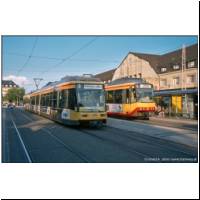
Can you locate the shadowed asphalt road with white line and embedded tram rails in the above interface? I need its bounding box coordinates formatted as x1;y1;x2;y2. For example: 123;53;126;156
2;108;197;163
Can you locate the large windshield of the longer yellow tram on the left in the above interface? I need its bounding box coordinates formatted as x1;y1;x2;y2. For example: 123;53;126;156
77;85;105;112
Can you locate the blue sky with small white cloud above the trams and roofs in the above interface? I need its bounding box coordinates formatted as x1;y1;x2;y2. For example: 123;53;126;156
2;36;198;92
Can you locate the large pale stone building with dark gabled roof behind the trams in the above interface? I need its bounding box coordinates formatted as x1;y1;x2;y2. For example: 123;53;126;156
96;44;198;118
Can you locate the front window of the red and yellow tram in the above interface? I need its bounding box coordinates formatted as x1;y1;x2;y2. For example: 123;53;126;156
136;88;153;102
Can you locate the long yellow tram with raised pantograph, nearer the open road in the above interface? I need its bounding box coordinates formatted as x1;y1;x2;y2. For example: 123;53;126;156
24;76;107;126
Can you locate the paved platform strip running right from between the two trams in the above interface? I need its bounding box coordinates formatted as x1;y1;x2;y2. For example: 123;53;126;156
107;118;198;148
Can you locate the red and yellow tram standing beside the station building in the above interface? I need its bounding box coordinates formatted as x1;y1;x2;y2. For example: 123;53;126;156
105;77;156;119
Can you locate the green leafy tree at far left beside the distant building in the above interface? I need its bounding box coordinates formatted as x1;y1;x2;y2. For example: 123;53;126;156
5;88;25;104
